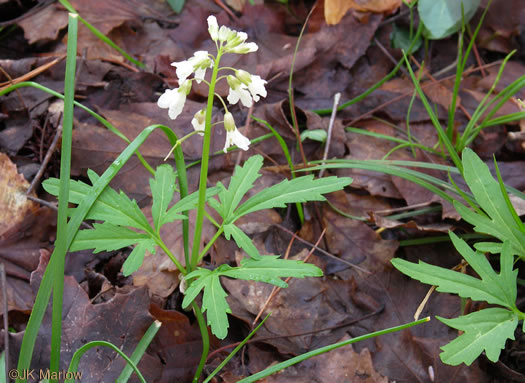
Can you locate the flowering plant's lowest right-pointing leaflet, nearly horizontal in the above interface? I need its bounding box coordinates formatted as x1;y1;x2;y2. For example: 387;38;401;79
221;255;323;287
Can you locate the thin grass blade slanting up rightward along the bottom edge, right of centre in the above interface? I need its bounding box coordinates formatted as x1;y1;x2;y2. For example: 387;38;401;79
237;317;430;383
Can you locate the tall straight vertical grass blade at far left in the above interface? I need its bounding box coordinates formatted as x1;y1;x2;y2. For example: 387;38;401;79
49;13;78;382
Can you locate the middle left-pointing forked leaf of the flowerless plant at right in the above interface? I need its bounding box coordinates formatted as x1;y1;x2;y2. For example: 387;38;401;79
392;232;518;308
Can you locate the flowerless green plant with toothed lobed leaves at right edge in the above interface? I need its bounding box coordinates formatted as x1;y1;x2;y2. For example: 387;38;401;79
392;148;525;365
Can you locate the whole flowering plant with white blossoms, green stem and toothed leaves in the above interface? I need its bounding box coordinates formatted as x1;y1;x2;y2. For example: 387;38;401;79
44;16;351;380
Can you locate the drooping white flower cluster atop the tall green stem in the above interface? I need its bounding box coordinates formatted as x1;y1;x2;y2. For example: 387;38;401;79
157;16;266;152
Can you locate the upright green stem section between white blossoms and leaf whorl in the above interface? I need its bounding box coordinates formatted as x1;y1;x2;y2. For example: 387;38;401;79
188;48;222;272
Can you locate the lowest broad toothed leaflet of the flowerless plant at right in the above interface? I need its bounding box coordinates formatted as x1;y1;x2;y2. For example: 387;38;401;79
437;308;518;366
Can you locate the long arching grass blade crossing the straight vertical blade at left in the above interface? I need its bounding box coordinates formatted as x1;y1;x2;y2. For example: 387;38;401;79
17;125;177;382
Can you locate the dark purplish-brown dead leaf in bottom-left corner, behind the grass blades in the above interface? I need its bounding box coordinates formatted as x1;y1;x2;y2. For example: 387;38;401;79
10;257;162;382
